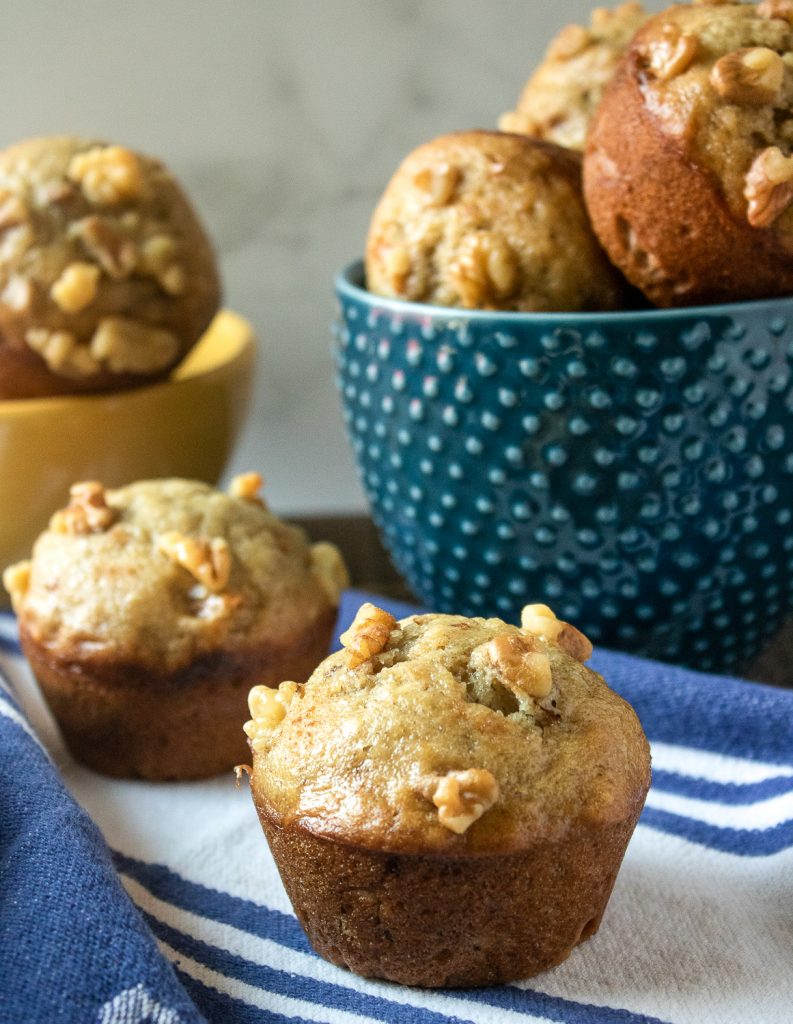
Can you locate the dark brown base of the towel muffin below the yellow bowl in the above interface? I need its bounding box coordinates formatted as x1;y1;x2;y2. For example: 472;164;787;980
19;609;336;781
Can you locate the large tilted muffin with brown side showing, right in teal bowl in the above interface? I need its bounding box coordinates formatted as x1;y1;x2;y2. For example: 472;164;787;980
584;0;793;306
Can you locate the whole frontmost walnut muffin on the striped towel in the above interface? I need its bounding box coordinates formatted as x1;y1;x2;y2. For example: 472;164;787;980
246;604;650;987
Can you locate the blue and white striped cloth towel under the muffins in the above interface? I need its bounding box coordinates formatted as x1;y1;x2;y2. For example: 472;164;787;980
0;594;793;1024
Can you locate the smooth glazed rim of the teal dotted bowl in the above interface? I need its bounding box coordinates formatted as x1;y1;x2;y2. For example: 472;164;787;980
334;259;793;326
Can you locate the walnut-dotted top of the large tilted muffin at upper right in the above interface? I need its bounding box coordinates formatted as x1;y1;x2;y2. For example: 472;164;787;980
627;0;793;232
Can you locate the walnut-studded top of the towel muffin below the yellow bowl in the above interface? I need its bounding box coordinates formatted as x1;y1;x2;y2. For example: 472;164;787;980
3;473;346;672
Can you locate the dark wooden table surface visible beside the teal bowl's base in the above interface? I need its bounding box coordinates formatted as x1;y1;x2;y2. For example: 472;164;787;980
296;515;793;687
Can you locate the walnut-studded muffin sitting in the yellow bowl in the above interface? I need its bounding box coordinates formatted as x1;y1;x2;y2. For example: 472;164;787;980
0;136;220;398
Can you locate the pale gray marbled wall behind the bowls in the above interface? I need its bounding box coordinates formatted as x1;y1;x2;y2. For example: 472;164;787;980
0;0;663;513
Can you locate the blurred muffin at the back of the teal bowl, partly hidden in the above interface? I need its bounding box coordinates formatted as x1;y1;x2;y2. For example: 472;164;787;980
499;0;650;150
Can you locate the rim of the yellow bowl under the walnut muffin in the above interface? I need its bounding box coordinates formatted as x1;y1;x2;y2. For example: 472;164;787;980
0;307;254;421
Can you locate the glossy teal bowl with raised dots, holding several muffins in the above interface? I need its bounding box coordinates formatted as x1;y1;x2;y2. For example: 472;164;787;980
335;262;793;671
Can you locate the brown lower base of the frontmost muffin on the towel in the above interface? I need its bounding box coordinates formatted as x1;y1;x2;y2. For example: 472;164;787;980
254;791;640;988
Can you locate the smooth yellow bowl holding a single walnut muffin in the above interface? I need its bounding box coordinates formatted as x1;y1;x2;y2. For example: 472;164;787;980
0;310;255;585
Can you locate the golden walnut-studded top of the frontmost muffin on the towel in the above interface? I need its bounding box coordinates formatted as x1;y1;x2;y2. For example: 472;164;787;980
246;604;650;853
